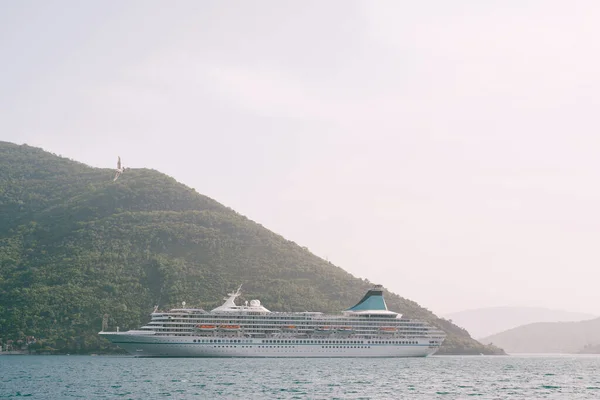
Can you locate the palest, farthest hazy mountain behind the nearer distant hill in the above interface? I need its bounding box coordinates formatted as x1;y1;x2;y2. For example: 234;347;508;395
444;307;597;343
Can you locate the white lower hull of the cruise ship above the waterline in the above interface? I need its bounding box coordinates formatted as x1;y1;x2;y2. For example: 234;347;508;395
100;332;438;358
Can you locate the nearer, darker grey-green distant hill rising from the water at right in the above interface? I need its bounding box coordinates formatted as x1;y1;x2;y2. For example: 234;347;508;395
480;318;600;353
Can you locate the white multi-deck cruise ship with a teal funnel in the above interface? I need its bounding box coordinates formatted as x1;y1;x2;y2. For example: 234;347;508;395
99;285;446;357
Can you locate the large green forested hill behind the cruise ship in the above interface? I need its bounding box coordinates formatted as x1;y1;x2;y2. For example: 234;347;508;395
0;142;502;354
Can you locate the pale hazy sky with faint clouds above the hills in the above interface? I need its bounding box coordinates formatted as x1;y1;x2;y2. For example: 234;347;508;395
0;0;600;314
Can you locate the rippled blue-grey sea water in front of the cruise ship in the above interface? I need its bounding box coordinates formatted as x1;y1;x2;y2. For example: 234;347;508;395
0;356;600;399
